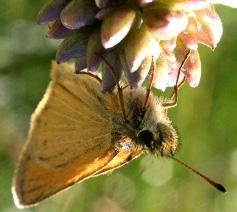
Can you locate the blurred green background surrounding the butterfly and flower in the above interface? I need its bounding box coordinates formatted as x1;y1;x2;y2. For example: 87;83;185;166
0;0;237;212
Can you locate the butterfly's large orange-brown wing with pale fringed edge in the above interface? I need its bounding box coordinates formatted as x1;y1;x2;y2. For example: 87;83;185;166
13;62;128;207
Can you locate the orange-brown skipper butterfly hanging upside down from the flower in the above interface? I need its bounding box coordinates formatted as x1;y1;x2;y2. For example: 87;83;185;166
12;51;226;208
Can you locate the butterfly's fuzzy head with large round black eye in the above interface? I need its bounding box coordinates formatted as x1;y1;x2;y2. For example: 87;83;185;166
137;123;178;156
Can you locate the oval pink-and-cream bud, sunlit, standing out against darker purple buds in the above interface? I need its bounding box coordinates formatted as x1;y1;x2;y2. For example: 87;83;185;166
101;7;136;49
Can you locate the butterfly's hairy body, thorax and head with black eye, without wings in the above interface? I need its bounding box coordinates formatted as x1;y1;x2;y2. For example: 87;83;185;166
112;90;178;156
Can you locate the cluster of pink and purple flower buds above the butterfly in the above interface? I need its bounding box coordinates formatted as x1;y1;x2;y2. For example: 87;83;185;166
38;0;234;92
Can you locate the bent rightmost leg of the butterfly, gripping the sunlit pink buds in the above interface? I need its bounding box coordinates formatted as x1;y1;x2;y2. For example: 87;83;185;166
162;50;191;109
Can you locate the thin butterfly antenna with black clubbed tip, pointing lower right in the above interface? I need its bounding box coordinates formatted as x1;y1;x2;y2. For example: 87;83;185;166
170;156;226;192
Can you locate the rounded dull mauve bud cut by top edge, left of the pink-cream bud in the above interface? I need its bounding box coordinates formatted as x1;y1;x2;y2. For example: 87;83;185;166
60;0;97;29
